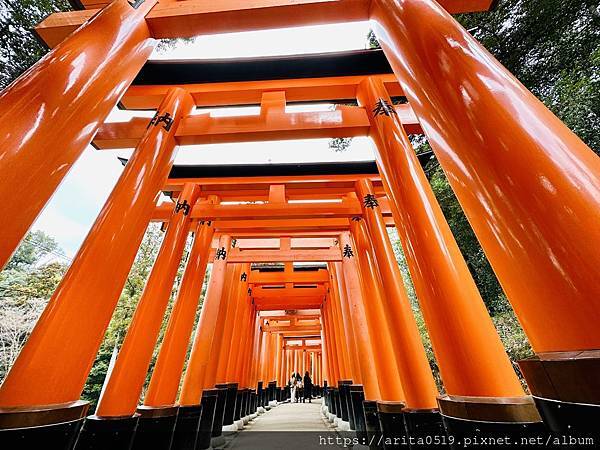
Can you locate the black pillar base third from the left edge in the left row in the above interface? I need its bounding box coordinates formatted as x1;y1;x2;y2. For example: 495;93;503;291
131;406;178;450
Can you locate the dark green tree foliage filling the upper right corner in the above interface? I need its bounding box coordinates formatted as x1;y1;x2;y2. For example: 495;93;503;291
458;0;600;153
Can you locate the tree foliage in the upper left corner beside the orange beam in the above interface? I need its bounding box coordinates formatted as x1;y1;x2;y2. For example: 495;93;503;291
0;0;70;89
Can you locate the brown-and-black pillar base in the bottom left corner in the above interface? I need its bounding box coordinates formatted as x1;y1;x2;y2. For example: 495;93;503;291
0;400;89;450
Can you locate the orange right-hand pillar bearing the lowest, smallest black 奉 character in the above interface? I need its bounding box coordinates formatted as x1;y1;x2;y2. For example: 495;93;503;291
338;232;381;400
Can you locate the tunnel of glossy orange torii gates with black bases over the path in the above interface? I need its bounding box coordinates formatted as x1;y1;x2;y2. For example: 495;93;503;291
0;0;600;449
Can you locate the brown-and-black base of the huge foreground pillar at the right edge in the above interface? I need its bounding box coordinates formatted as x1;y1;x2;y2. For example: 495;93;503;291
519;350;600;435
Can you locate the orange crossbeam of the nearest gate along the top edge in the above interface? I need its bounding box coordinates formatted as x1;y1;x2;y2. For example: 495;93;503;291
35;0;493;47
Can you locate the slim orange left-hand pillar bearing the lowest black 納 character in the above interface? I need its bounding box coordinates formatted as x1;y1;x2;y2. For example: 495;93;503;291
179;235;231;405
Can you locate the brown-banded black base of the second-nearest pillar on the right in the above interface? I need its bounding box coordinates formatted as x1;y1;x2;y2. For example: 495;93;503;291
438;396;547;448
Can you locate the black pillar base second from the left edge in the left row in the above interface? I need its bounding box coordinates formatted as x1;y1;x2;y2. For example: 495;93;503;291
73;414;139;450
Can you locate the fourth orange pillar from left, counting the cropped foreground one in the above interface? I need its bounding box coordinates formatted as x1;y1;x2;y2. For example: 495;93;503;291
144;218;214;406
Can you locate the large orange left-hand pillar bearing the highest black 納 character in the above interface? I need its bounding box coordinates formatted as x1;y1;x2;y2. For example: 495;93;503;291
0;89;193;407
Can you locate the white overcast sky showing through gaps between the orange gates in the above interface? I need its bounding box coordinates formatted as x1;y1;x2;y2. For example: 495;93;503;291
32;22;373;258
